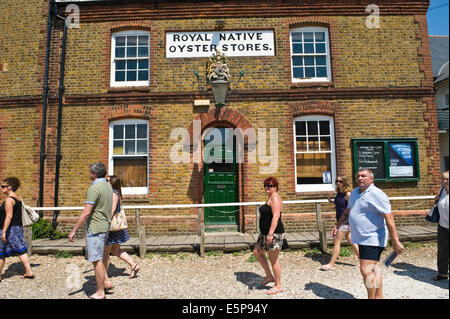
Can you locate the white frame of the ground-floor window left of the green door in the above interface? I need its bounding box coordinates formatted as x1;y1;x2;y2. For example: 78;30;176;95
108;119;150;195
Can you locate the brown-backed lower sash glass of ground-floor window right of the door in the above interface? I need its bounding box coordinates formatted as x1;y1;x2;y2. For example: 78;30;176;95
296;153;331;184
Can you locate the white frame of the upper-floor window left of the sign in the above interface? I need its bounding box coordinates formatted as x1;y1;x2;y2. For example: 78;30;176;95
110;31;151;87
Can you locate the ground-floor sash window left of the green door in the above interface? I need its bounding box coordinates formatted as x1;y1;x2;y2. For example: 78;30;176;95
109;119;148;194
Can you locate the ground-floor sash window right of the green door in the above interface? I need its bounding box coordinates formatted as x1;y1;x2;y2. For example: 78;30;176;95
294;116;337;192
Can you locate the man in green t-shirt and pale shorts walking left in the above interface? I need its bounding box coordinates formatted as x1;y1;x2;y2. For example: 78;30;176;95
69;162;113;299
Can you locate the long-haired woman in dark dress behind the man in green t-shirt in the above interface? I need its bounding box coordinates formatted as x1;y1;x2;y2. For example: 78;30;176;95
103;175;140;287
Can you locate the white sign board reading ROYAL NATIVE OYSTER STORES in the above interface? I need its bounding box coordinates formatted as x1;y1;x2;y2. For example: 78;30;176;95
166;30;275;58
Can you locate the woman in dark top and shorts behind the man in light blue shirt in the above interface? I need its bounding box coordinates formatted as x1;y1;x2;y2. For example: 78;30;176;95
320;176;359;271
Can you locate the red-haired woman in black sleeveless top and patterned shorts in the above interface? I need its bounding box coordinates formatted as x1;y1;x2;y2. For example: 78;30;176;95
253;177;285;295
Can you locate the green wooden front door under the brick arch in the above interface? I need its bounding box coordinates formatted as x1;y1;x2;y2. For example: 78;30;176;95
203;128;239;225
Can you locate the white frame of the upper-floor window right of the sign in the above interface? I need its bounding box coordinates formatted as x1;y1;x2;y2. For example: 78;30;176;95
289;27;332;83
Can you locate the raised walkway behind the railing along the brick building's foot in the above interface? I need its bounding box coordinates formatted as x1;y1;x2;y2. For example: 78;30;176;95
33;225;437;255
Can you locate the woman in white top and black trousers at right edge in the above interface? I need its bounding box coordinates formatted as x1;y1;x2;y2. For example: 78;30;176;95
433;171;449;280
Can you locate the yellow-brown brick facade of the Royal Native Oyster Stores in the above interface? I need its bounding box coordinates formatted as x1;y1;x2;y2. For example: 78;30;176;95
0;0;439;238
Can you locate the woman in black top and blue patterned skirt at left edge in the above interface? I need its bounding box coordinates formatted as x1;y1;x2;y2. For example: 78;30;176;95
0;177;34;281
